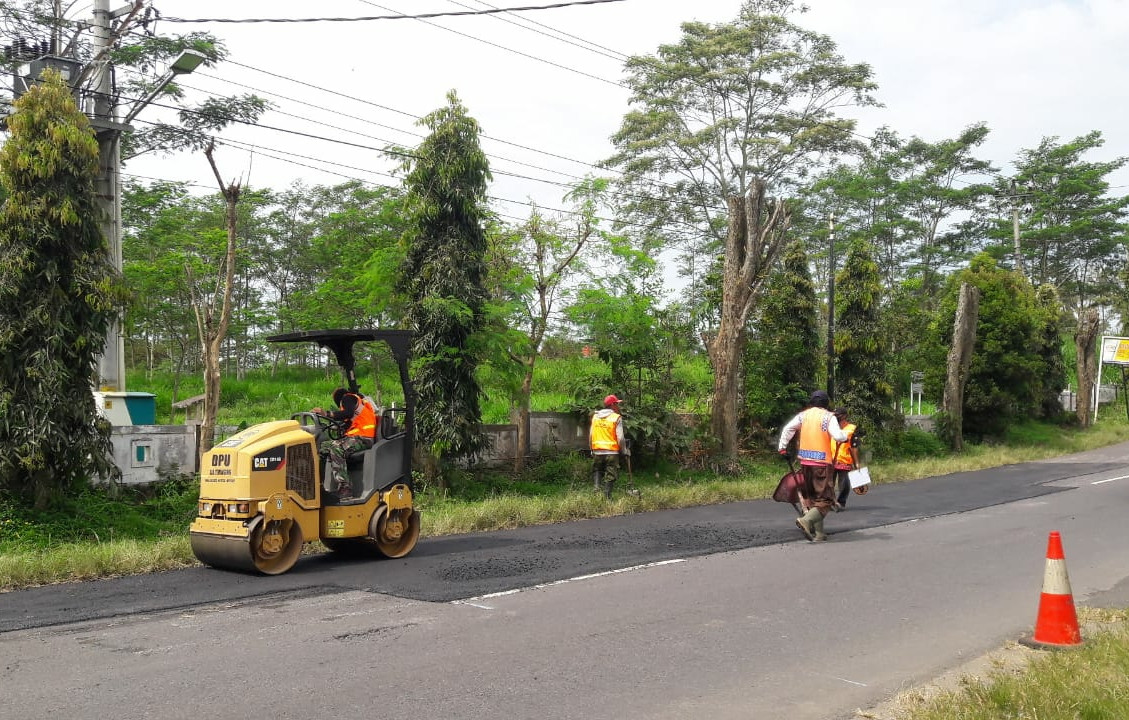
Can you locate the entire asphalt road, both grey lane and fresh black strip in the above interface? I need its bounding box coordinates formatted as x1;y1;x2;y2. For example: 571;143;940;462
0;444;1129;720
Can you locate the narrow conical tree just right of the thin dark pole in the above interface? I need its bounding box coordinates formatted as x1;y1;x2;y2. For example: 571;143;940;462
834;239;894;430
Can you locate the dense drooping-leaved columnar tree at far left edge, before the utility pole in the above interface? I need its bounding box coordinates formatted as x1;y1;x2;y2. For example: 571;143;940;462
0;72;124;508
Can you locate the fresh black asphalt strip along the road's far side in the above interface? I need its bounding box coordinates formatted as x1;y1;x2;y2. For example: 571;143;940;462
0;462;1124;632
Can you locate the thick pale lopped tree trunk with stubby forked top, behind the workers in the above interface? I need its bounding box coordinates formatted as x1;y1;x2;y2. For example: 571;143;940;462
707;178;791;459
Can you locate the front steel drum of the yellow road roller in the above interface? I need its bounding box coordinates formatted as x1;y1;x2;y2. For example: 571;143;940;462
189;516;304;576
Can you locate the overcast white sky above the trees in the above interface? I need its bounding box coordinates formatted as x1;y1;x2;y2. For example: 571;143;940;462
124;0;1129;225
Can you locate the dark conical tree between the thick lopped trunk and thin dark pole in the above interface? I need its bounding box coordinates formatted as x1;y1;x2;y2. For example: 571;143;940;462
744;240;823;428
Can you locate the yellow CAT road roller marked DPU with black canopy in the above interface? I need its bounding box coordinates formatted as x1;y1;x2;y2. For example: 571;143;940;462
189;330;420;574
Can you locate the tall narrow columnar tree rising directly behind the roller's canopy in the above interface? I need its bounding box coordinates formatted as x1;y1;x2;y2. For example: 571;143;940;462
399;90;490;482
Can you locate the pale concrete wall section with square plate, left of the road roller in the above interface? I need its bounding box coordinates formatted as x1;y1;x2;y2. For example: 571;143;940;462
110;425;198;485
